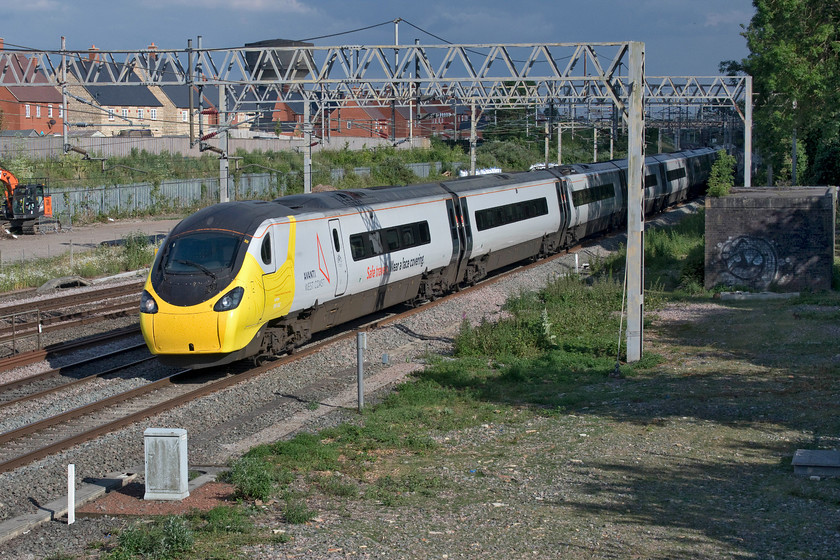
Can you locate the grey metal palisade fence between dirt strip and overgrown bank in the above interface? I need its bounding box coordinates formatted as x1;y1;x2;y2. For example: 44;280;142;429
51;161;463;227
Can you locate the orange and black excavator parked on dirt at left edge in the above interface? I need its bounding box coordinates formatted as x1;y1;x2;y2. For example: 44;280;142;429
0;168;60;233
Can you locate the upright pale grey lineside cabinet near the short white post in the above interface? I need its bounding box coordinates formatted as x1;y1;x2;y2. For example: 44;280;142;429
143;428;190;500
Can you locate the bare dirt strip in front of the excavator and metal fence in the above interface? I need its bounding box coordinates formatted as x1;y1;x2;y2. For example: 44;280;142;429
0;218;180;264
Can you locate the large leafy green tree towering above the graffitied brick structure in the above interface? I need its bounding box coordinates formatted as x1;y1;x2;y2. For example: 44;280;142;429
736;0;840;184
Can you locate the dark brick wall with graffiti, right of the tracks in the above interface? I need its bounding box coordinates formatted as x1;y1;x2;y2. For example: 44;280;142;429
705;187;837;292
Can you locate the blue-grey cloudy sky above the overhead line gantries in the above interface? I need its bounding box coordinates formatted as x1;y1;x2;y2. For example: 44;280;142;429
0;0;755;76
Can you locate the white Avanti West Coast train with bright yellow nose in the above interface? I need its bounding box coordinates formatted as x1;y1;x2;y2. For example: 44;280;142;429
140;148;716;369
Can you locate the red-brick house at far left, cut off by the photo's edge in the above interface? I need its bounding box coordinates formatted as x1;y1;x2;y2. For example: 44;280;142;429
0;39;64;135
